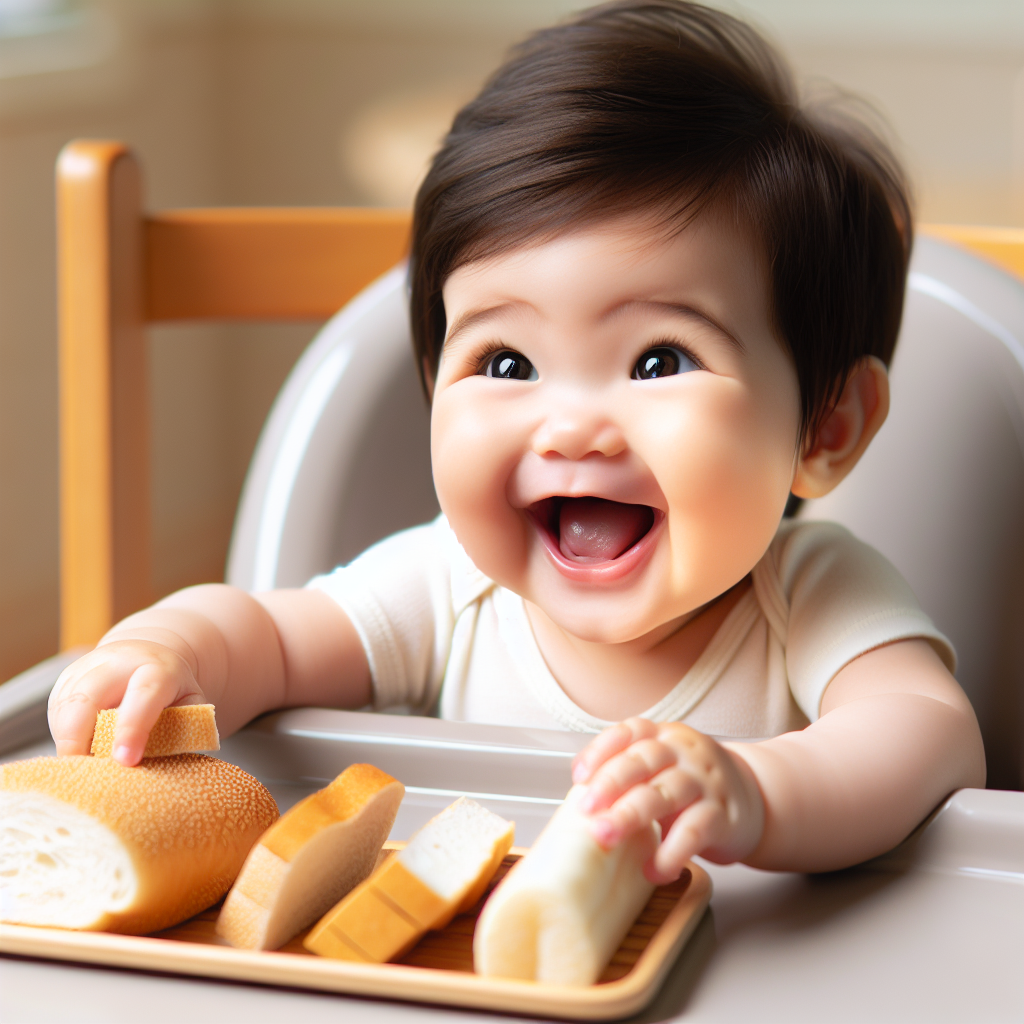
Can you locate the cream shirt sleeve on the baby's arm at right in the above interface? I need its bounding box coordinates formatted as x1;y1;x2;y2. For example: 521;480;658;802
772;522;956;722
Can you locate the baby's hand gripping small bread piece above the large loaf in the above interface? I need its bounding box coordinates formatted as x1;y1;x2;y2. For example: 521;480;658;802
48;631;207;766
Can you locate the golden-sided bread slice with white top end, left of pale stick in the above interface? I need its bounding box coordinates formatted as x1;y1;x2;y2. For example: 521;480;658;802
303;797;515;964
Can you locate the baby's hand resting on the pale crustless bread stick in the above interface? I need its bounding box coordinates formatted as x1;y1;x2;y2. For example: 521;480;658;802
572;718;765;885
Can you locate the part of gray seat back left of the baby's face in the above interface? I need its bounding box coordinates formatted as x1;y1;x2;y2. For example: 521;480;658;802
226;266;438;591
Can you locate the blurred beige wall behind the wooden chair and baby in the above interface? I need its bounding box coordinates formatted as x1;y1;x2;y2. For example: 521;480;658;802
0;0;1024;679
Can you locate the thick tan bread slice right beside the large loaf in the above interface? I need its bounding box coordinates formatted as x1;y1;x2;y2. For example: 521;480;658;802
217;765;406;949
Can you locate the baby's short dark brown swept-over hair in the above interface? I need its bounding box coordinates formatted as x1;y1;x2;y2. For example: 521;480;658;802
410;0;911;438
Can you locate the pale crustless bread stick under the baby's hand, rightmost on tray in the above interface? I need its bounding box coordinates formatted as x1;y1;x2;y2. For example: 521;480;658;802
473;786;660;985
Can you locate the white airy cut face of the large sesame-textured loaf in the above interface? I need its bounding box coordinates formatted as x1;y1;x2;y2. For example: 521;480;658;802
0;792;138;928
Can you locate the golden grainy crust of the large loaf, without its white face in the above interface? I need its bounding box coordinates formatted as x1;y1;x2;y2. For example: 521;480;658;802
0;754;278;935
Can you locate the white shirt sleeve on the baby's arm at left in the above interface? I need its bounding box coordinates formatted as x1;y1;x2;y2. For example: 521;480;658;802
306;519;454;713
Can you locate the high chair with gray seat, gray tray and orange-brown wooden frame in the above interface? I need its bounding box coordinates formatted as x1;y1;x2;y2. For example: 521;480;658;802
0;142;1024;1022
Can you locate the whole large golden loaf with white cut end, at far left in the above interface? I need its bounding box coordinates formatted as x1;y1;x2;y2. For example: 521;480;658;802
0;754;278;935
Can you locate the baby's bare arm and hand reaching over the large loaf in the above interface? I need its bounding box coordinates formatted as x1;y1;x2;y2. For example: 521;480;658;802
49;584;370;765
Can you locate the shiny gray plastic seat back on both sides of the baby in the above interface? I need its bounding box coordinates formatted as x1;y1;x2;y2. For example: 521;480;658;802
227;238;1024;788
